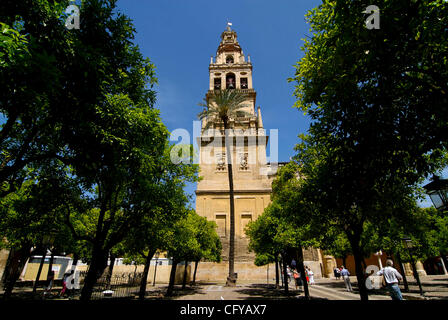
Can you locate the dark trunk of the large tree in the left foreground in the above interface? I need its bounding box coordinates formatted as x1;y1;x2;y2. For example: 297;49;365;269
80;244;109;301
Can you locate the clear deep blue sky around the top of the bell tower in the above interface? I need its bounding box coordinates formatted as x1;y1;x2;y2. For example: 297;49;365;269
114;0;440;206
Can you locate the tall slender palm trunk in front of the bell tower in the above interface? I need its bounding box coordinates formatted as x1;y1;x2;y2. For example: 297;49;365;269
224;119;236;287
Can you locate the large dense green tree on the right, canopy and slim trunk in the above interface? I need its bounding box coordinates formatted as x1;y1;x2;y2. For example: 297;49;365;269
291;0;448;299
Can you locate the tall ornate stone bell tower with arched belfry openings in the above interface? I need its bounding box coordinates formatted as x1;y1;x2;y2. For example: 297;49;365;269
196;26;274;280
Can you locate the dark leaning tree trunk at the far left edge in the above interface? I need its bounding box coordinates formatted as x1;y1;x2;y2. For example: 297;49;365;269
3;246;31;300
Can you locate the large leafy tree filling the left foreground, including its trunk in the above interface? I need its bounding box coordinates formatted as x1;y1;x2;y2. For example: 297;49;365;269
0;0;196;300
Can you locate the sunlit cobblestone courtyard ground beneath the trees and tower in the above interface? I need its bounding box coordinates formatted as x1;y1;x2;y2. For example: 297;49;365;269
0;276;448;300
